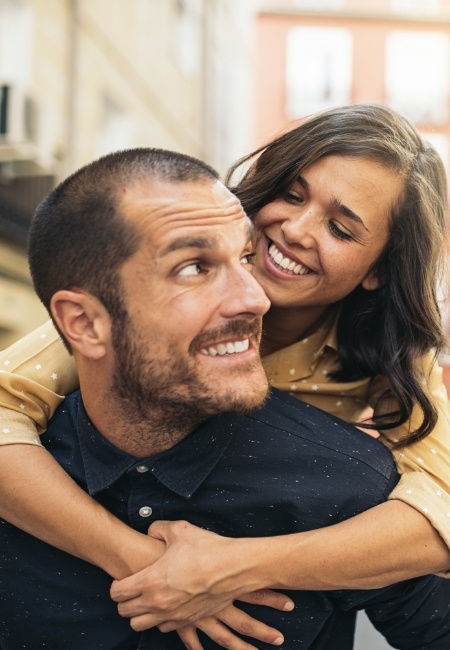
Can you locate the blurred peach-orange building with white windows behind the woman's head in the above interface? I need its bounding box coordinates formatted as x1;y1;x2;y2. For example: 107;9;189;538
253;0;450;167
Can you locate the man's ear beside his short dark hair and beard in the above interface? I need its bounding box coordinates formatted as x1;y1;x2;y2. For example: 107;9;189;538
50;289;111;360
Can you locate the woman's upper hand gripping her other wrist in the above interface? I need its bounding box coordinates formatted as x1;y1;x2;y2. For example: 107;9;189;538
111;521;293;632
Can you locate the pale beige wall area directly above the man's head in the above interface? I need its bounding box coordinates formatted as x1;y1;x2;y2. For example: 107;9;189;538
22;0;255;175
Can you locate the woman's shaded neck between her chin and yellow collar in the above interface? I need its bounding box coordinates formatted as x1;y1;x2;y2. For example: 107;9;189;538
261;306;330;357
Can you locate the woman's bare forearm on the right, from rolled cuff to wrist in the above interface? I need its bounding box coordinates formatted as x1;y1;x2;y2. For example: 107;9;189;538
258;500;450;590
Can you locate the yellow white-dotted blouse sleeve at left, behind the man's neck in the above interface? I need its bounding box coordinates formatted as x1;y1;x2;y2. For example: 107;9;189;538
0;321;78;445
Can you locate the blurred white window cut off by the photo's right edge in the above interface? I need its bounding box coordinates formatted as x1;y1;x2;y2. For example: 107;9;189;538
386;31;450;124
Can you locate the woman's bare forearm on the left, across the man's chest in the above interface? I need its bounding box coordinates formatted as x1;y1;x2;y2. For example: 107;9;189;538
0;445;163;579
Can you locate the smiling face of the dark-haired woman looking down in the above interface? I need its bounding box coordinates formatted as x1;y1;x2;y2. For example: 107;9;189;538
254;155;404;308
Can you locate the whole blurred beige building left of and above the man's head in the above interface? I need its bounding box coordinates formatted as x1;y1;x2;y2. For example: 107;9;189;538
0;0;254;348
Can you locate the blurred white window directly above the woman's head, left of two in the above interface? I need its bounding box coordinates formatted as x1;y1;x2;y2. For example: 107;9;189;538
286;27;352;119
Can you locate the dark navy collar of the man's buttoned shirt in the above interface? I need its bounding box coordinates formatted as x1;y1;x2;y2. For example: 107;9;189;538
77;397;233;498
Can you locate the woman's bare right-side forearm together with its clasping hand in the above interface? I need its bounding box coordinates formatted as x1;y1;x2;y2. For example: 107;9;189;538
111;500;450;631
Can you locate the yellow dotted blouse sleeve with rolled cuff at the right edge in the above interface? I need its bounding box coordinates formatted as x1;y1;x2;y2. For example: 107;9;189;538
372;354;450;556
